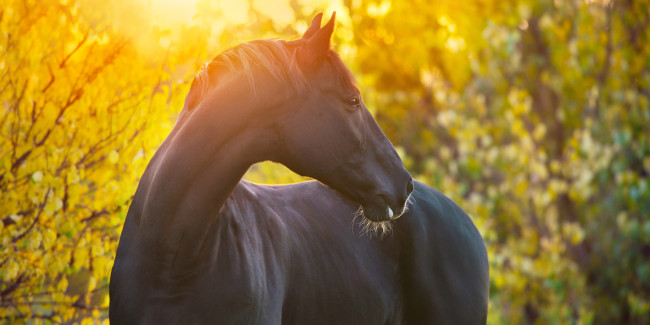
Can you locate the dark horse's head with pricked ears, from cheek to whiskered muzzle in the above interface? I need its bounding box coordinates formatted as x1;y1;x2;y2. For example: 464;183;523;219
273;14;413;221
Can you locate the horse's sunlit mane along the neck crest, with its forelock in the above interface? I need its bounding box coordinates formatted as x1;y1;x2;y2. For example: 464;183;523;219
185;39;355;110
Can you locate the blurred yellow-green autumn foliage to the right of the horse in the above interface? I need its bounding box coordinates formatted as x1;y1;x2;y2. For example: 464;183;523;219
348;1;650;323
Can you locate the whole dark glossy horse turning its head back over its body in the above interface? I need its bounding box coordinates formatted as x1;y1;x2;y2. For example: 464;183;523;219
110;14;488;324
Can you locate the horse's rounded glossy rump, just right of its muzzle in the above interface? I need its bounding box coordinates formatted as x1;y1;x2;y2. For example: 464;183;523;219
398;183;489;324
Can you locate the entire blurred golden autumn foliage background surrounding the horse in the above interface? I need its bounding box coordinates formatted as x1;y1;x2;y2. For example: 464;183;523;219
0;0;650;324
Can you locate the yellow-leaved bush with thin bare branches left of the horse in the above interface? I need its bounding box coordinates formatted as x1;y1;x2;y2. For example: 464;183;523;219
0;1;196;322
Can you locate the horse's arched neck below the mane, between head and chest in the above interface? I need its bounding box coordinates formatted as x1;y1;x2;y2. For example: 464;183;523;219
132;73;280;258
